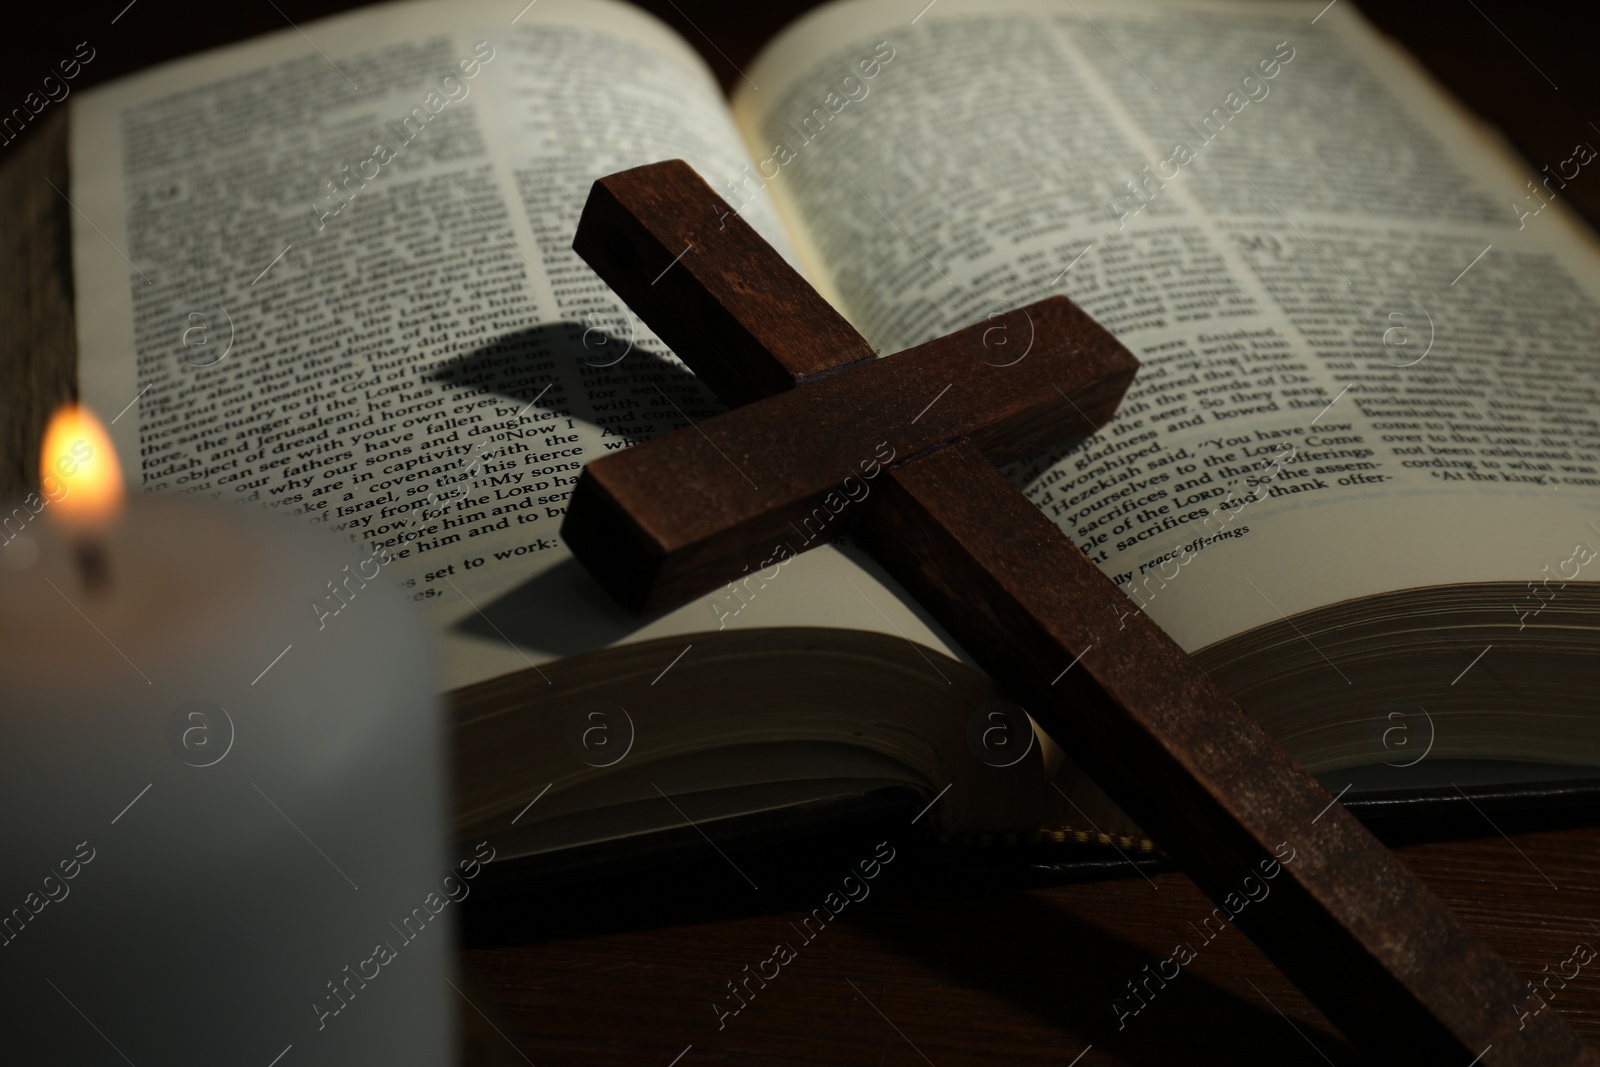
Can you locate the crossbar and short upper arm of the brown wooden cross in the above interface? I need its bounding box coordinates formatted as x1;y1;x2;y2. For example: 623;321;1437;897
562;160;1138;611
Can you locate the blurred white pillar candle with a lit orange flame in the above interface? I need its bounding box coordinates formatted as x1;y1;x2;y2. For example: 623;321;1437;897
0;408;451;1067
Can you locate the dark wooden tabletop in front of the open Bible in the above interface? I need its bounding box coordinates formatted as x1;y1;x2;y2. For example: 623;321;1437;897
462;825;1600;1067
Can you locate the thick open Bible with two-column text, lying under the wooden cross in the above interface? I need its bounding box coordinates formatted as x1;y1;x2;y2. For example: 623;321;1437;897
70;0;1600;857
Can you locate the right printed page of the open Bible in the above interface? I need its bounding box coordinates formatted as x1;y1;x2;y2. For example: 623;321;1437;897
734;0;1600;652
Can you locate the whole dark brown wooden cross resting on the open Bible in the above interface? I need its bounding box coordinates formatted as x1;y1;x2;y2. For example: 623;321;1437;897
562;160;1600;1067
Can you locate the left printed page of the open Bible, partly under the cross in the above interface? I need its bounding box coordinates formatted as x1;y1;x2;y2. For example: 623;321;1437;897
70;0;966;686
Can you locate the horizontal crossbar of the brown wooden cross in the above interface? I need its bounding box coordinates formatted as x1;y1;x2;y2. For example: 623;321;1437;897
562;298;1138;611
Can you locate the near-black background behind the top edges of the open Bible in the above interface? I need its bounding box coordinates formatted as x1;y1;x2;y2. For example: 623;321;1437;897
9;0;1600;224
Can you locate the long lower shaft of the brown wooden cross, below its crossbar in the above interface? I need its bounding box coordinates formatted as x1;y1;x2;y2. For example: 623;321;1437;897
858;442;1600;1064
